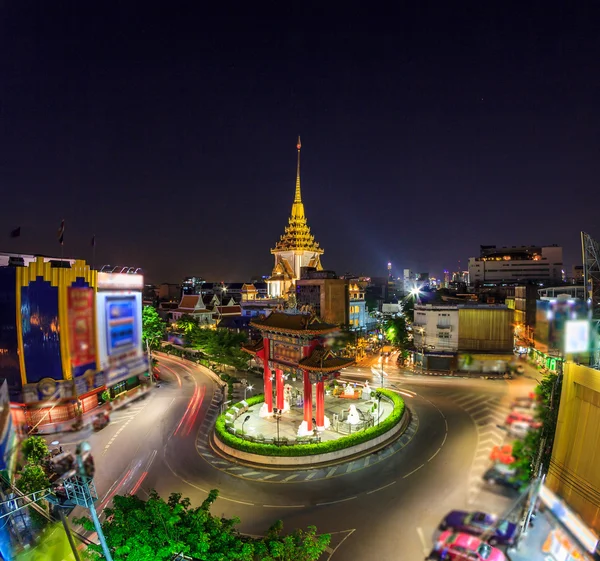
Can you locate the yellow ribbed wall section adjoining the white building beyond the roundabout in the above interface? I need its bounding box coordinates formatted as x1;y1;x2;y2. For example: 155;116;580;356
458;308;514;352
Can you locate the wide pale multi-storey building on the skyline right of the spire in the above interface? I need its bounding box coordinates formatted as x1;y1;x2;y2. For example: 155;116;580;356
469;245;563;285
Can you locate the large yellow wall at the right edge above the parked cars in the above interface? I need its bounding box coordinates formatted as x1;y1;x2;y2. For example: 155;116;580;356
547;362;600;533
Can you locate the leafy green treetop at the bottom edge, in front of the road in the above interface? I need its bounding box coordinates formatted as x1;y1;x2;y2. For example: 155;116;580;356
75;490;330;561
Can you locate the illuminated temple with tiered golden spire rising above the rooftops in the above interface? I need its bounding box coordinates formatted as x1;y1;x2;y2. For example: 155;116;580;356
267;137;323;298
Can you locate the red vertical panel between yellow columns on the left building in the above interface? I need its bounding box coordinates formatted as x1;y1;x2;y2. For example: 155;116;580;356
67;287;96;377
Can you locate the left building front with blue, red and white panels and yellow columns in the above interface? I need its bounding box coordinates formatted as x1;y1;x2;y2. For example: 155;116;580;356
0;257;148;432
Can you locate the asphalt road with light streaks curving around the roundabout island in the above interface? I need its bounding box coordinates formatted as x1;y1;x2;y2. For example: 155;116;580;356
71;358;534;561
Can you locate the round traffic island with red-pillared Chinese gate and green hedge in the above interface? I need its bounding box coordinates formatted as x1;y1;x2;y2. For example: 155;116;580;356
214;310;410;469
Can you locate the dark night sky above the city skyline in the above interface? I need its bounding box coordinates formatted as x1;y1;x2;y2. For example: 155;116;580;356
0;4;600;282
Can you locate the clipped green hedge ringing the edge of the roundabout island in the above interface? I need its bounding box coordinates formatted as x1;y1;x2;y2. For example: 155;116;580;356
215;389;404;456
